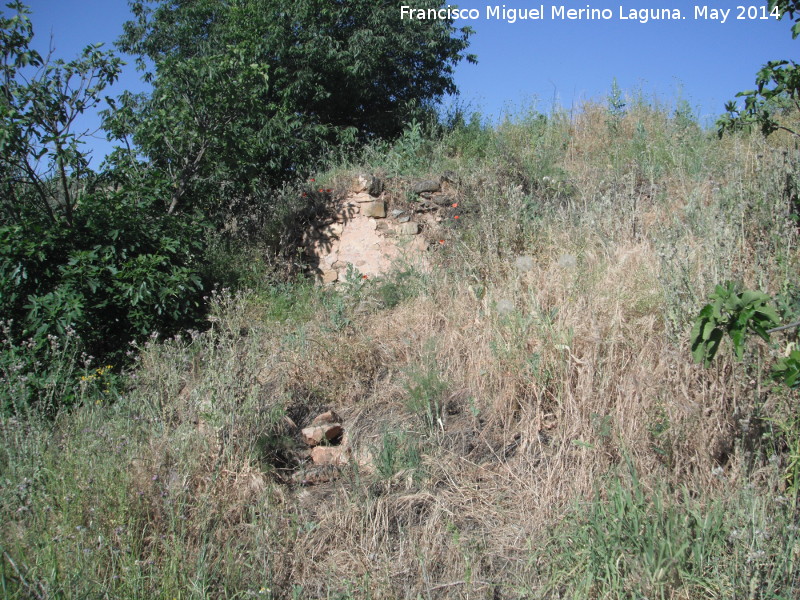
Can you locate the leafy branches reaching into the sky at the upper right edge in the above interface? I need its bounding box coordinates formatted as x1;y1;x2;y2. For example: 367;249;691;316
717;0;800;137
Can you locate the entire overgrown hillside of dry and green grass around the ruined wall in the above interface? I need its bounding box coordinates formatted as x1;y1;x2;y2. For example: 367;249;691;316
0;98;800;600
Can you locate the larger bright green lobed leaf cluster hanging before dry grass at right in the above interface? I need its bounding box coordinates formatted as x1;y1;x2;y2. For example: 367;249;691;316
690;282;779;367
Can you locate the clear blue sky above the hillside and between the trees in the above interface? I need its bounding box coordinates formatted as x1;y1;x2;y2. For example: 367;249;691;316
17;0;800;166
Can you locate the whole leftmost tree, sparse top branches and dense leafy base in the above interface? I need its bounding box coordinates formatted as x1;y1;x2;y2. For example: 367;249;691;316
0;2;206;411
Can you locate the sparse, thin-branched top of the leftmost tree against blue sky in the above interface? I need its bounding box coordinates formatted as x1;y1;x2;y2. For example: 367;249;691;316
0;0;122;227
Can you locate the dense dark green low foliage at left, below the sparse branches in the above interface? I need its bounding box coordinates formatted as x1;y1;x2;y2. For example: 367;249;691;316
0;192;205;410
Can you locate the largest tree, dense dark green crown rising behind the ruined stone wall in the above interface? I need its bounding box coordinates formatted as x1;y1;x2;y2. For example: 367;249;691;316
109;0;475;216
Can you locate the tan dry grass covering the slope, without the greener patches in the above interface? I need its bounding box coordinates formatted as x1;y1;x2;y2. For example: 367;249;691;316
3;101;800;599
